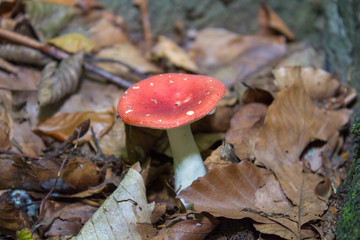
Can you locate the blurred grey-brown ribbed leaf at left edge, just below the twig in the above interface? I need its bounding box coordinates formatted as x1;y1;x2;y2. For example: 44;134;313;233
0;44;51;66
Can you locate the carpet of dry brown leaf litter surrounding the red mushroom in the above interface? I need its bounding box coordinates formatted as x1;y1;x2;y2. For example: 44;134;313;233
0;0;357;239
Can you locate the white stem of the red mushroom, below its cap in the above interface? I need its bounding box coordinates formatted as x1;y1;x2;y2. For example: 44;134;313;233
167;124;206;197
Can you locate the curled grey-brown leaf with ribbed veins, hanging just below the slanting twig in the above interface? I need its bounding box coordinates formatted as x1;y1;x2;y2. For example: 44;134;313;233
38;52;84;106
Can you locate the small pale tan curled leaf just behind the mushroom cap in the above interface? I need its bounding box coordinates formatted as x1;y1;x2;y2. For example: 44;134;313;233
152;36;198;73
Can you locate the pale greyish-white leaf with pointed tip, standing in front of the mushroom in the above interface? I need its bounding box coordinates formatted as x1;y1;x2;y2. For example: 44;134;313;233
72;168;155;240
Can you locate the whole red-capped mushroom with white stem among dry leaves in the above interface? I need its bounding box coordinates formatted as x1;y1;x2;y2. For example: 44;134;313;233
118;73;226;206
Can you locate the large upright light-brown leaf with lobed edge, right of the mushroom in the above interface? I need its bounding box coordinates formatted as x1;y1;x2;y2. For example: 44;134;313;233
255;81;342;204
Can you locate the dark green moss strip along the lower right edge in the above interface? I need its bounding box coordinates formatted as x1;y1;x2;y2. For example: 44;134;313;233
337;113;360;240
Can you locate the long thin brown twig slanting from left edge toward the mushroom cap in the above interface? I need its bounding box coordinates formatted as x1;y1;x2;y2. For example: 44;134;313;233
0;28;133;88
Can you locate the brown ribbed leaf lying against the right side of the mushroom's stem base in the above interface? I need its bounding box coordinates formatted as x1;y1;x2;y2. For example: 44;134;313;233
177;161;269;220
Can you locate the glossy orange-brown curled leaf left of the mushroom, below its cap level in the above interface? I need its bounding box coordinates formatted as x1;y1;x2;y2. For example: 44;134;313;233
34;106;115;141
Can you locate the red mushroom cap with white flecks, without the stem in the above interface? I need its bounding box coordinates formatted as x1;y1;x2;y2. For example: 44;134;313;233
118;73;226;129
